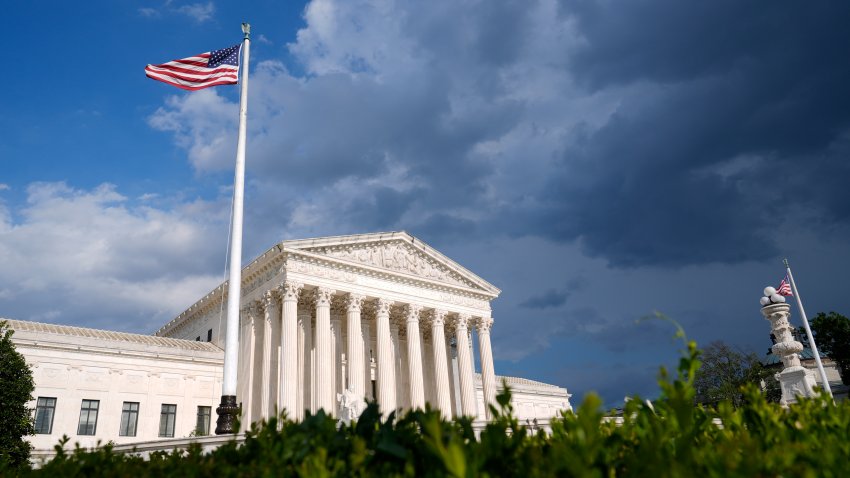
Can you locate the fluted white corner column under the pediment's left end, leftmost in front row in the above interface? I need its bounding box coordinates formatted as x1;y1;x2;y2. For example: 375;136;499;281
280;281;304;419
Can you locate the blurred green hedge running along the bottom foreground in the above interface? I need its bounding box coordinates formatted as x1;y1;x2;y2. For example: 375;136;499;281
6;336;850;478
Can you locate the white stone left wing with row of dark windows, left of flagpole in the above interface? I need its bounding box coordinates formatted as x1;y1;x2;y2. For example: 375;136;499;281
8;320;224;457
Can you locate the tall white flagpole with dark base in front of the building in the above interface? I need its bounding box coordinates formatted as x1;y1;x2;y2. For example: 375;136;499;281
215;23;251;435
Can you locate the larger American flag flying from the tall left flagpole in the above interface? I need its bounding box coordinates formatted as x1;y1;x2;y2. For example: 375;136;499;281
145;44;242;91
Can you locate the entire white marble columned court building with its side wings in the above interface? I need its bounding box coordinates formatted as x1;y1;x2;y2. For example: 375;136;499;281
9;232;570;449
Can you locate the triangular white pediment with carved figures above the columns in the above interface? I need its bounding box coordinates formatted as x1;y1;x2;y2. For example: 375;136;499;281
281;232;500;296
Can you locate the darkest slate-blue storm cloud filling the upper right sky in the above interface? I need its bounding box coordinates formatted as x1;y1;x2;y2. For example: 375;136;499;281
523;1;850;266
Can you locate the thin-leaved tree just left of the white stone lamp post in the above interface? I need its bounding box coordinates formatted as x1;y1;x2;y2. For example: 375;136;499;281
694;341;779;408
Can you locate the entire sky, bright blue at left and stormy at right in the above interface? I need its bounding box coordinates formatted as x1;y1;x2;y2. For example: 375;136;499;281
0;0;850;404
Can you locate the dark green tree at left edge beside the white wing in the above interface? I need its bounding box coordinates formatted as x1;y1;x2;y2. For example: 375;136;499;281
0;321;35;469
